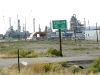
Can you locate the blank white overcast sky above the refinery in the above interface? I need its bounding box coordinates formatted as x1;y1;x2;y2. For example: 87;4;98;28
0;0;100;34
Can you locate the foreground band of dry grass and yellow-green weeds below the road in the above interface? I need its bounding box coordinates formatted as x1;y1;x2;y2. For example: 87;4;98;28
0;59;100;75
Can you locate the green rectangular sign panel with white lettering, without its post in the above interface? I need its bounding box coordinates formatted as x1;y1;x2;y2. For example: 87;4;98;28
52;20;67;29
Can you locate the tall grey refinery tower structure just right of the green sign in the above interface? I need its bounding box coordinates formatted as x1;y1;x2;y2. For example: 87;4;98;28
70;14;85;40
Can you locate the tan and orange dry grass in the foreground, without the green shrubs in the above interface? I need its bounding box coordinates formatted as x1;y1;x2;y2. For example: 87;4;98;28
1;63;100;75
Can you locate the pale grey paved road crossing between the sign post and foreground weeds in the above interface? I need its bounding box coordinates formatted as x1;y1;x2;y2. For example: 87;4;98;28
0;56;96;69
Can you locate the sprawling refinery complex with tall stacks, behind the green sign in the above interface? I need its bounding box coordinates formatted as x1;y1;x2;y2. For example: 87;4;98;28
0;14;95;40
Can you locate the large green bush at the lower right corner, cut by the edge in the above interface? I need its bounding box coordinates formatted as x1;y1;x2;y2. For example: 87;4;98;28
88;57;100;72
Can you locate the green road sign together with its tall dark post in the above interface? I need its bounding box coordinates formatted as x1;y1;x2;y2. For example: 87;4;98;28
52;20;67;57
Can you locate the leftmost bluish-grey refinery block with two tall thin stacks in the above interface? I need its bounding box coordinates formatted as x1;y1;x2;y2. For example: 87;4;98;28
4;18;30;40
